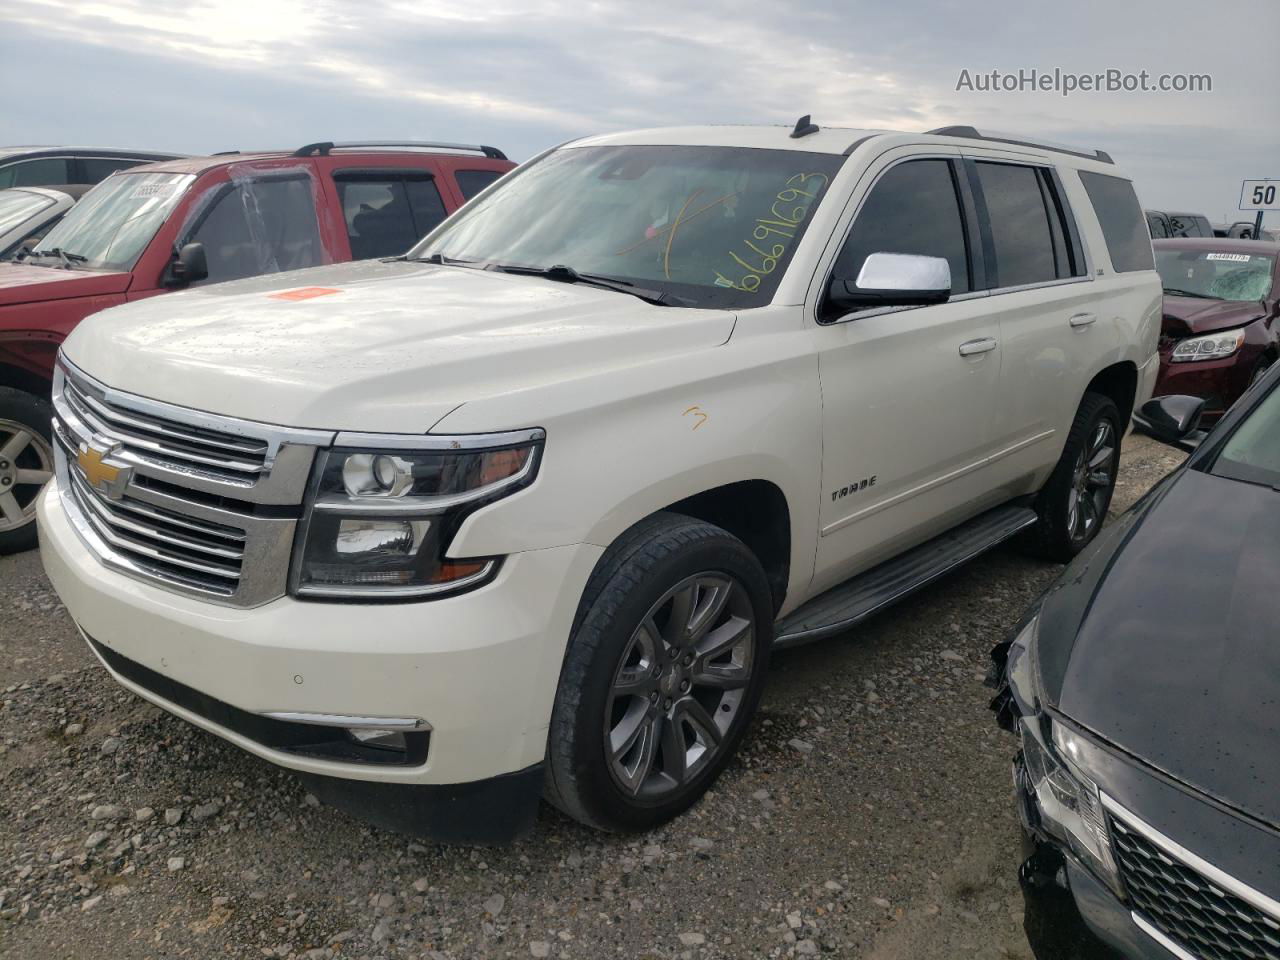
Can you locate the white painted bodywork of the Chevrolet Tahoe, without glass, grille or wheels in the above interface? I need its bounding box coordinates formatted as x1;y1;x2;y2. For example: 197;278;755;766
41;127;1160;782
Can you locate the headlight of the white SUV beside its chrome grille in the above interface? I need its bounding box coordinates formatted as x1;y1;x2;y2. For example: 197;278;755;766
292;430;544;599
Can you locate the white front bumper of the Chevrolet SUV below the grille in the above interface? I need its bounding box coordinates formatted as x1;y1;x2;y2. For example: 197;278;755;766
37;481;602;792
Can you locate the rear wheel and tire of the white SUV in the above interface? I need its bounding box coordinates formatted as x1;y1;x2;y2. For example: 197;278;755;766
1024;393;1124;563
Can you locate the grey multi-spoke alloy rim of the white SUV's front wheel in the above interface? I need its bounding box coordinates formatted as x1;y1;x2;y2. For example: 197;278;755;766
604;572;755;800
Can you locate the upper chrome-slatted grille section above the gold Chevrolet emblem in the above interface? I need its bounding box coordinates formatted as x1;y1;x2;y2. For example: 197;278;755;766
63;366;269;486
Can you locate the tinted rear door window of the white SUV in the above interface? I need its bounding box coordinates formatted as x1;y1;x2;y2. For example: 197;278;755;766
974;161;1073;287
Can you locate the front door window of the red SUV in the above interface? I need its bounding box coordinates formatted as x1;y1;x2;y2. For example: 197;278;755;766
178;175;325;283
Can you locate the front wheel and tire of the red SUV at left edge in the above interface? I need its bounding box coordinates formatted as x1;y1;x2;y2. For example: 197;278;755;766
0;387;54;554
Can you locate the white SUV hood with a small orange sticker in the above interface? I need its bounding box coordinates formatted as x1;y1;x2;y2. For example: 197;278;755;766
63;261;735;433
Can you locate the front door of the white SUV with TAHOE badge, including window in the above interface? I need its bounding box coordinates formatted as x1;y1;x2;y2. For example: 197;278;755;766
814;157;1001;590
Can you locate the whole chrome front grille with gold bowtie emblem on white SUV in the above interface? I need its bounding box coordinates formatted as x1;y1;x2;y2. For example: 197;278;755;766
54;361;333;607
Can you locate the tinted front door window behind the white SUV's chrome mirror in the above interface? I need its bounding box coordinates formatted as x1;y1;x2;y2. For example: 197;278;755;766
835;160;970;293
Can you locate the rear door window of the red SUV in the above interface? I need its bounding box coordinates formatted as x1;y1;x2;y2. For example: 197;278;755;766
334;170;447;260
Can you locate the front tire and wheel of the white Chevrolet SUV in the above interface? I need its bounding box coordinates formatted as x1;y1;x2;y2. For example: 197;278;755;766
544;513;773;832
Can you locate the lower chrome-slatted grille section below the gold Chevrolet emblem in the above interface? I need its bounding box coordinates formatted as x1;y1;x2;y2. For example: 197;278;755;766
67;467;246;596
